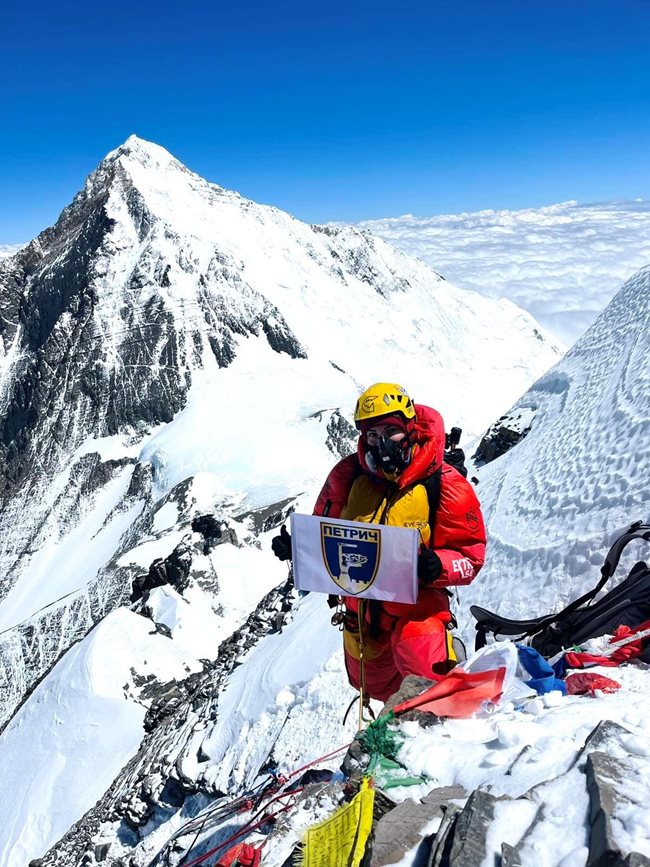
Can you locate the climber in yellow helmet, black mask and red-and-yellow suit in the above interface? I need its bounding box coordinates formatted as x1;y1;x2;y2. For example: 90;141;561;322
272;383;485;701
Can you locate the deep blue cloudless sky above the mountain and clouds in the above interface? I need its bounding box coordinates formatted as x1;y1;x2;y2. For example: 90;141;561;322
0;0;650;243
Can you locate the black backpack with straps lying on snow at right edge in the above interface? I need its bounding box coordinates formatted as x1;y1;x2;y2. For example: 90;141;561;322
470;521;650;659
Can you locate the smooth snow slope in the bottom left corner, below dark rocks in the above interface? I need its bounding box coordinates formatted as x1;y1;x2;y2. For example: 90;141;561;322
0;608;201;867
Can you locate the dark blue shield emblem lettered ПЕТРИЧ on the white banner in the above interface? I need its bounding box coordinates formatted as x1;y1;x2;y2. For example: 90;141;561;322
320;521;381;596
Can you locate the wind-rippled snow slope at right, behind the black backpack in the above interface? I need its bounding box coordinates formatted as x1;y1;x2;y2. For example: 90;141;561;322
462;267;650;622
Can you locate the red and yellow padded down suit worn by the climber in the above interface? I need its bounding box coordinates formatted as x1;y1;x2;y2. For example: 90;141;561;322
314;404;486;701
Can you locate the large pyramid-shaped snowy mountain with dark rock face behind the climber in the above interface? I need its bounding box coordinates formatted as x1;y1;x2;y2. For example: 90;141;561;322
0;137;559;701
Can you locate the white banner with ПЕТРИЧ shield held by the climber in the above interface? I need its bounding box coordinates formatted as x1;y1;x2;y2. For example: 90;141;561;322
291;513;420;603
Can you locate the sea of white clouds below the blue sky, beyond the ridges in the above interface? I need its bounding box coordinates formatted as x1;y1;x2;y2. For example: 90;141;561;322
359;199;650;346
